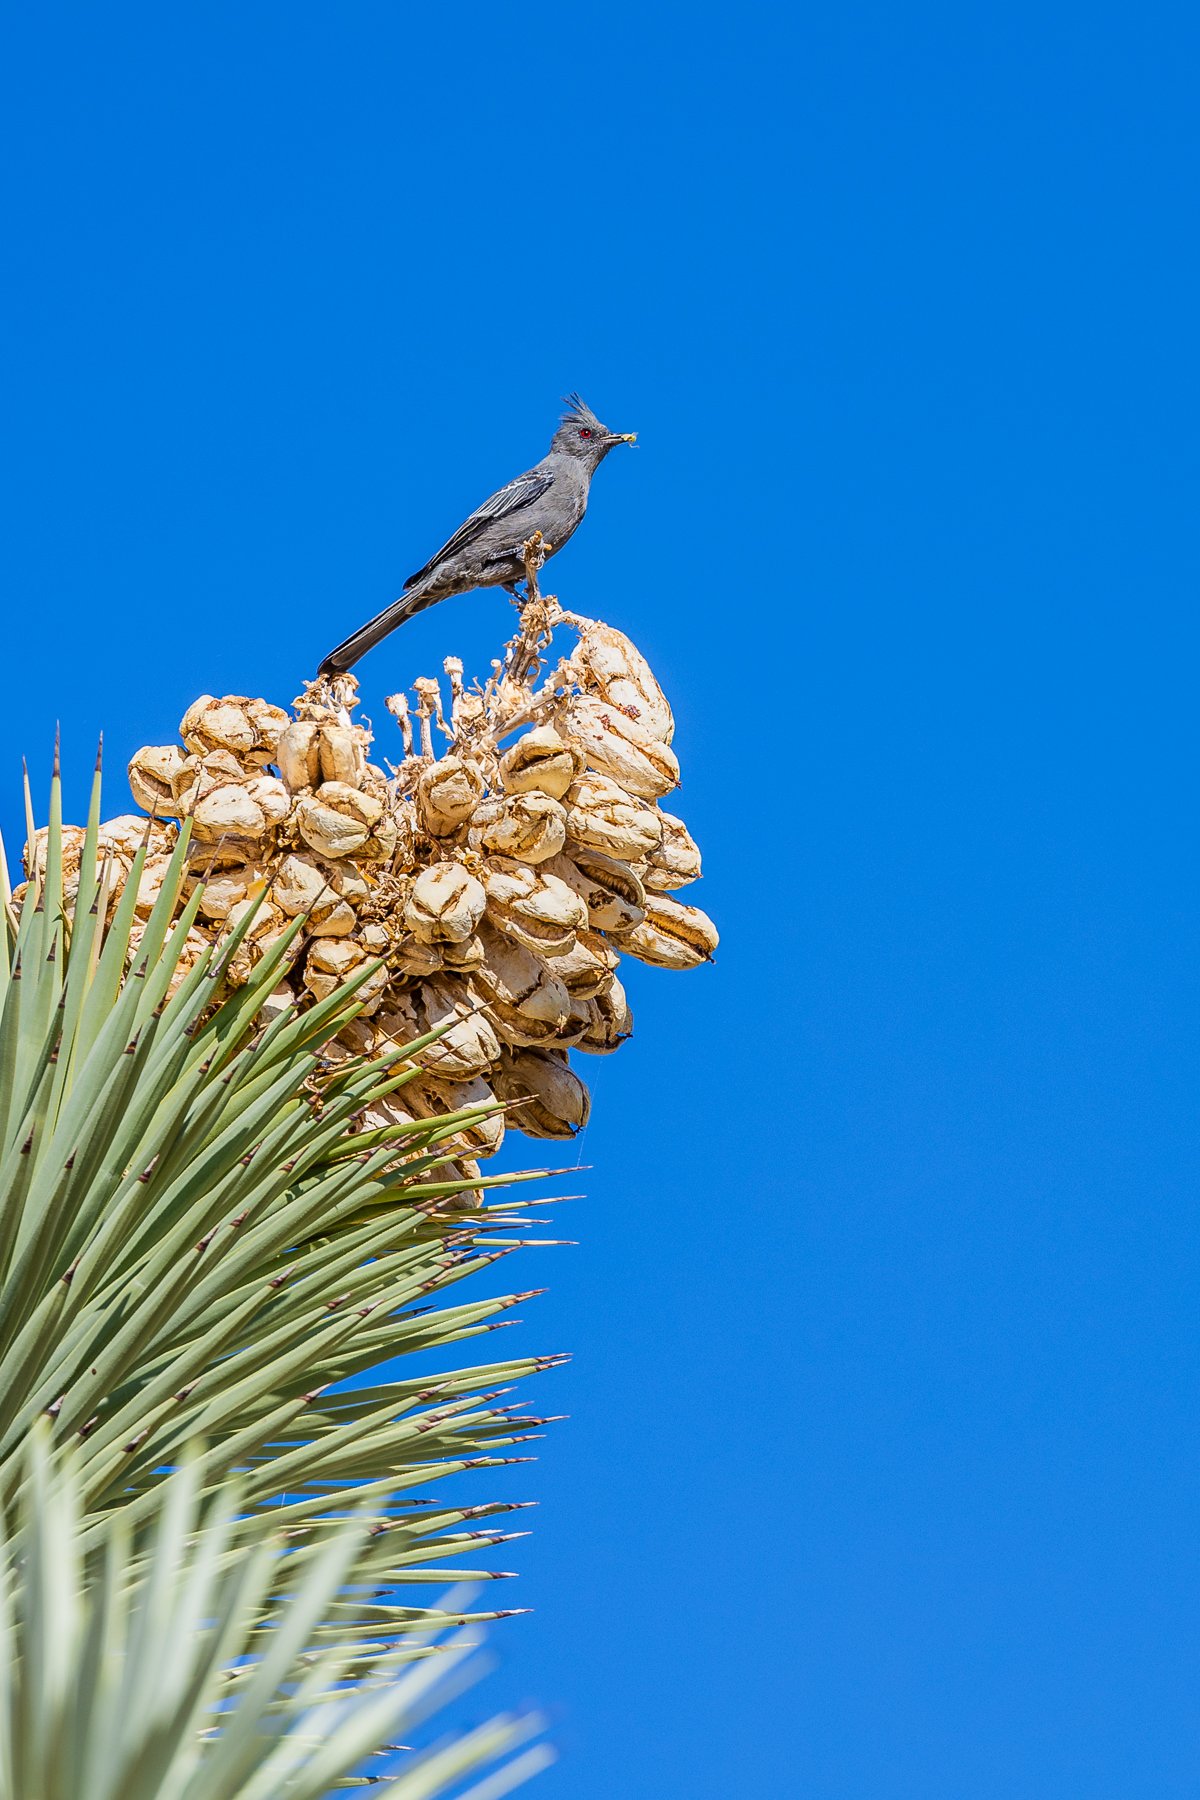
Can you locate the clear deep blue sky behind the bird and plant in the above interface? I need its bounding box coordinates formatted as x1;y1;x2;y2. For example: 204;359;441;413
0;0;1200;1800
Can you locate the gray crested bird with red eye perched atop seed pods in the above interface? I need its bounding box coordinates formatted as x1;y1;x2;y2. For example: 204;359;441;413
318;394;637;675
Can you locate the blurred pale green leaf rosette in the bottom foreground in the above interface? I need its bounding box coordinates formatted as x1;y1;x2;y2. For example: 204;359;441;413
0;1422;552;1800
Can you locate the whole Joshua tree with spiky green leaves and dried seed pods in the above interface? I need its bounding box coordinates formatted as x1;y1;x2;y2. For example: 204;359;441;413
0;545;716;1800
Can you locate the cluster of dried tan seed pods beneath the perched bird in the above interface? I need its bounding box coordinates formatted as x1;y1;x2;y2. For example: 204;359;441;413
31;585;716;1170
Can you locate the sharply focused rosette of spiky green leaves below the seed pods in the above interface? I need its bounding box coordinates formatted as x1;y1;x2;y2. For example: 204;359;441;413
0;756;560;1795
